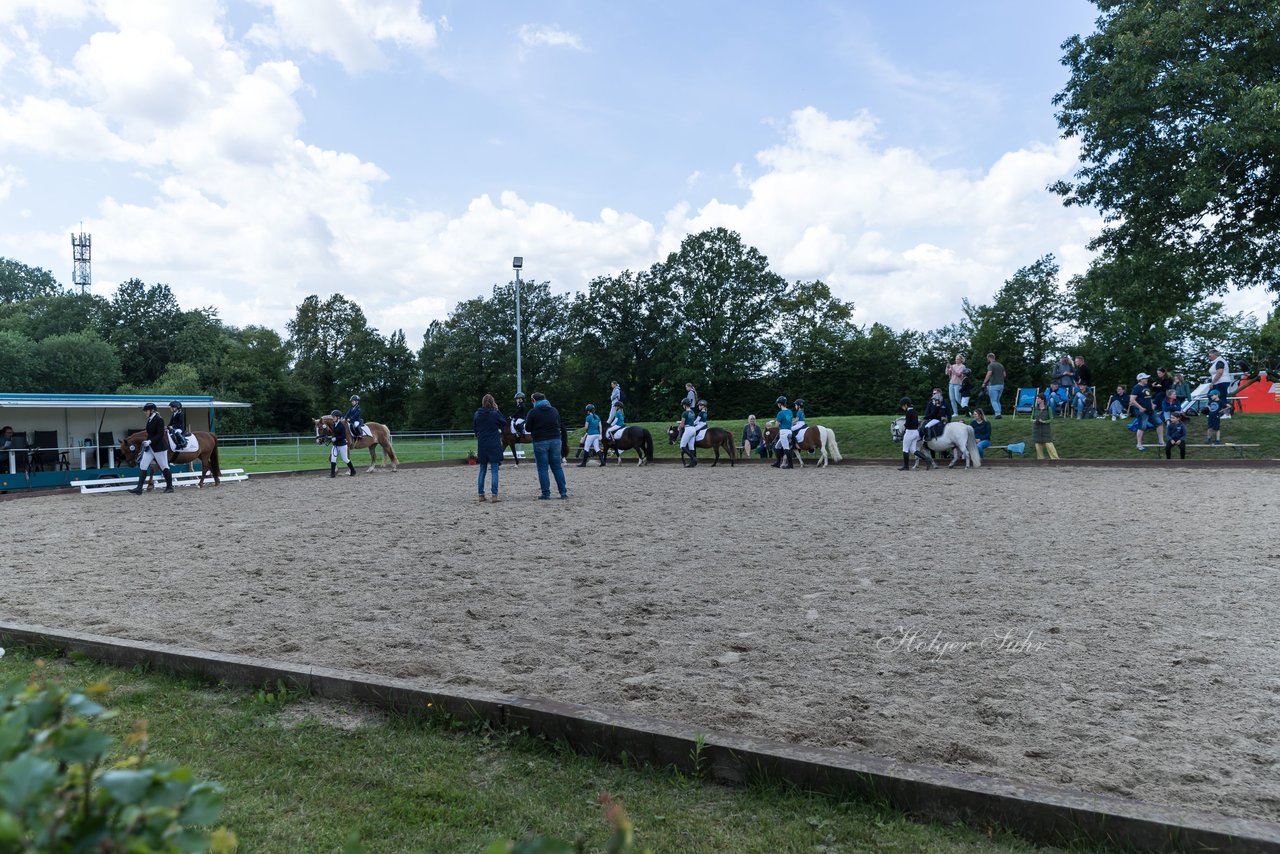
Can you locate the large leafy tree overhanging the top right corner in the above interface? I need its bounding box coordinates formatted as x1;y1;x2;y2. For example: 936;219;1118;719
1052;0;1280;300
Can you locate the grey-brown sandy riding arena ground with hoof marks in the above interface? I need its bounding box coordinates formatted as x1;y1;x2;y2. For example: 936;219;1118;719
0;461;1280;821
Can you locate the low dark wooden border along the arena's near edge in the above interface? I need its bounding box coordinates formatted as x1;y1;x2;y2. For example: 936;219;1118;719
0;622;1280;853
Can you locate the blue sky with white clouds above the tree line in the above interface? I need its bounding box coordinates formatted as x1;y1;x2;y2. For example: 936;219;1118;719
0;0;1121;346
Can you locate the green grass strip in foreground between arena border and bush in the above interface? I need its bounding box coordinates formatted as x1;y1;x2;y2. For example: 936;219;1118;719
0;649;1049;851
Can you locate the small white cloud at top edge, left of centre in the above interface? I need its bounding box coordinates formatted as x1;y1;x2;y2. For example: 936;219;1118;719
250;0;437;72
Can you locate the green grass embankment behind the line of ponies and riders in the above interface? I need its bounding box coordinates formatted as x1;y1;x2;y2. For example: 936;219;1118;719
221;414;1280;471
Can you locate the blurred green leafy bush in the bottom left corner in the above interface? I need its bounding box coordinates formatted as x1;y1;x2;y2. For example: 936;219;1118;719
0;660;236;853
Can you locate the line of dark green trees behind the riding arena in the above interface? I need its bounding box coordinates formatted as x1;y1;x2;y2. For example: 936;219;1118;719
0;228;1280;433
